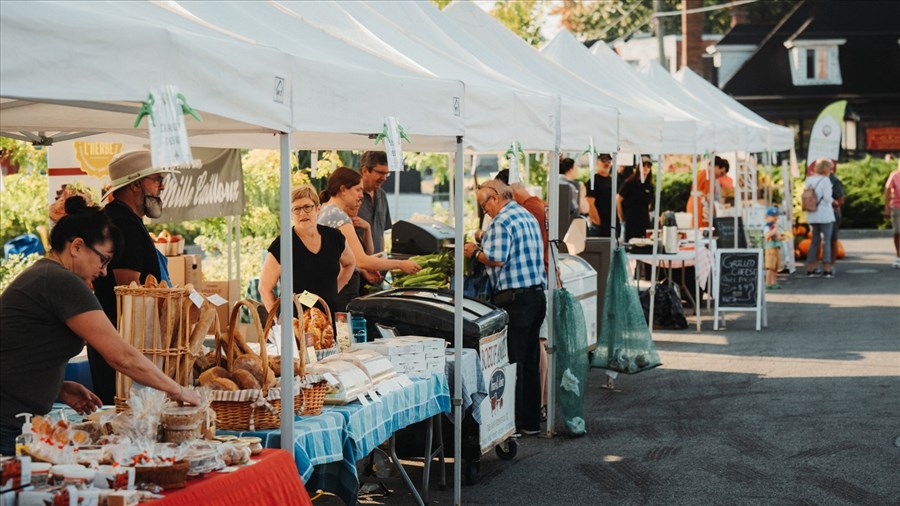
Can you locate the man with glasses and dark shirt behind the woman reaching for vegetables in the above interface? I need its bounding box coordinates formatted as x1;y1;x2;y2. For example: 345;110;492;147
359;151;392;284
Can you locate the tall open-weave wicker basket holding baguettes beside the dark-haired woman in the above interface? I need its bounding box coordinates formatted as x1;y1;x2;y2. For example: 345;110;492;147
115;275;193;411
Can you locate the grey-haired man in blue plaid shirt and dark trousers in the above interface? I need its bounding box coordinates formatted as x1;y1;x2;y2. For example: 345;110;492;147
463;179;547;435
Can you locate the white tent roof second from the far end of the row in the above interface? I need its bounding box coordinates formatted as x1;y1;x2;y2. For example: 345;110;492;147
638;60;756;152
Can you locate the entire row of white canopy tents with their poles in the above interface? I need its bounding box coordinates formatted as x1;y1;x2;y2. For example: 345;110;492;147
0;1;793;504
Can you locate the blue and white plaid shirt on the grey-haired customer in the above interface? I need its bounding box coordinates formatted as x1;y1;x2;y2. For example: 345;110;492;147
481;200;545;292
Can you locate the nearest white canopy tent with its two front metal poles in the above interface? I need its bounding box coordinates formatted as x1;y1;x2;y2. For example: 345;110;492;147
0;2;465;502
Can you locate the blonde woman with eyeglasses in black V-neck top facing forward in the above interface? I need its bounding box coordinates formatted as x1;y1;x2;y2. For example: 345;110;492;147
259;184;356;321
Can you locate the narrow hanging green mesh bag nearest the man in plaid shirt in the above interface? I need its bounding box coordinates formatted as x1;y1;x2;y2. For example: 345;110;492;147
553;289;588;436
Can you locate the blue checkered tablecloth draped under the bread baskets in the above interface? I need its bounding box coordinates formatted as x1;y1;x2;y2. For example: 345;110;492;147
219;374;450;505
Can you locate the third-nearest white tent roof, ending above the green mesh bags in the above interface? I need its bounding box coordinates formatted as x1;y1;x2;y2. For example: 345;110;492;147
443;2;663;153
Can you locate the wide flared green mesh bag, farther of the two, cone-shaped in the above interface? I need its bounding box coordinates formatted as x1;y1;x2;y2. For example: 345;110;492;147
592;248;660;374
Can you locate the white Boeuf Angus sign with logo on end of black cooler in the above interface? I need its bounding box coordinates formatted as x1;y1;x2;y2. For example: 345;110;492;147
479;329;516;453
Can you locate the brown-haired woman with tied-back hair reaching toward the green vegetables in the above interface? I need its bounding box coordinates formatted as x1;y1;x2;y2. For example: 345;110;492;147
319;167;421;311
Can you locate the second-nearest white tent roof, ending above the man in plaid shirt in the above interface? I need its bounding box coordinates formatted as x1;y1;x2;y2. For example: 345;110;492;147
270;2;557;152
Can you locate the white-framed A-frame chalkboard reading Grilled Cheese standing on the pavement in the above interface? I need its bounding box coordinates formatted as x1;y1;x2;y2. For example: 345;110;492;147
713;248;768;330
